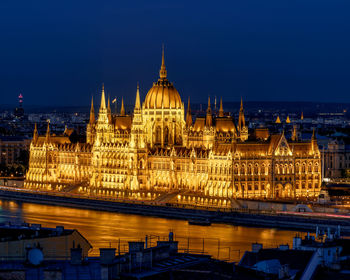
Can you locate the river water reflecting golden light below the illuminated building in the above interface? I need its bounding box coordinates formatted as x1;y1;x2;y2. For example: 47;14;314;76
0;200;304;261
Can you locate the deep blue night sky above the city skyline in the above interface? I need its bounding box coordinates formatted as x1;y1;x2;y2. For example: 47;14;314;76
0;0;350;106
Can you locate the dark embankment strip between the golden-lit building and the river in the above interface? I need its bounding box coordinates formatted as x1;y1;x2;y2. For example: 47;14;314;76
0;187;350;236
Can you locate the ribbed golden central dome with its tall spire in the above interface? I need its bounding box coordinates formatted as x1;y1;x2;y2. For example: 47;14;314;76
144;51;182;109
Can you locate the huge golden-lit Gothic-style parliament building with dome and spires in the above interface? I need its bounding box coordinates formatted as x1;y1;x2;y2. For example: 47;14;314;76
25;53;321;206
